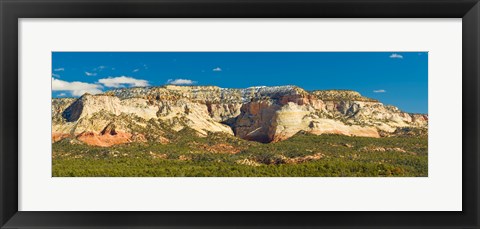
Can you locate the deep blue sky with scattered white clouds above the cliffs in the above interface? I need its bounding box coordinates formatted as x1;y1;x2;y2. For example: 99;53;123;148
52;52;428;113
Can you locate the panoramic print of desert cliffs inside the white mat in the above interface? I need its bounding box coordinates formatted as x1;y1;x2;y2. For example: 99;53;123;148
51;52;428;177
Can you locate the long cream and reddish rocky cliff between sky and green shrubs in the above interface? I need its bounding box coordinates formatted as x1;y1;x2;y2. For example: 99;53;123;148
52;86;428;146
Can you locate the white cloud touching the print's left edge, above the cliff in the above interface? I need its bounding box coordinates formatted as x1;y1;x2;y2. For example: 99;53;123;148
52;77;102;96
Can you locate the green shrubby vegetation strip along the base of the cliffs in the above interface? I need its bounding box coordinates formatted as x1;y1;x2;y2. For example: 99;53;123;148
52;130;428;177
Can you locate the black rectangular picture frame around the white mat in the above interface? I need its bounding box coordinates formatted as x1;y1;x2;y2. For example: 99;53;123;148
0;0;480;228
